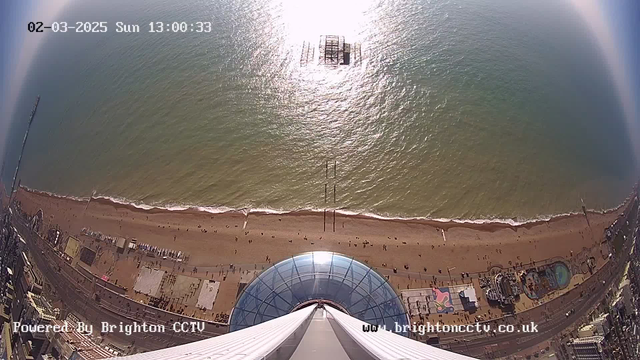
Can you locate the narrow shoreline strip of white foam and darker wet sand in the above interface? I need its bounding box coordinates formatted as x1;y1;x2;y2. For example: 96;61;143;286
20;185;635;231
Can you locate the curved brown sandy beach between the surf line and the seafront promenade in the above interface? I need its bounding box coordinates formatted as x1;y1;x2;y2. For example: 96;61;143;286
12;189;619;274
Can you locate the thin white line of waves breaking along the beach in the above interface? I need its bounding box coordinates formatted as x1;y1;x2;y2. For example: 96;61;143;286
21;186;633;227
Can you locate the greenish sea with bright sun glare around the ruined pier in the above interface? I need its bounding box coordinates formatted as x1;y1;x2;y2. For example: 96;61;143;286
3;0;636;219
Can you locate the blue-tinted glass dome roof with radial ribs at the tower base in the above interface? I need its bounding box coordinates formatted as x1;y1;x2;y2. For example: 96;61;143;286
230;251;408;335
